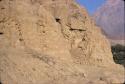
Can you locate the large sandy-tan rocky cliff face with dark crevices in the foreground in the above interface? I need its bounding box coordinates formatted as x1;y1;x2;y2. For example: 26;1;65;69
0;0;124;84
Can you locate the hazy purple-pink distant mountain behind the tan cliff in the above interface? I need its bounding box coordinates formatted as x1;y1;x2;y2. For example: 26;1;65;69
94;0;125;40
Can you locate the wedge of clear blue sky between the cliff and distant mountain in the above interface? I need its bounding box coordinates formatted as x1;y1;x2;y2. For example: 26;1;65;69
76;0;106;14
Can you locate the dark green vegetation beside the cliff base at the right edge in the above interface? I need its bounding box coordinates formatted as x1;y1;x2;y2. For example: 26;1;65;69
111;44;125;66
